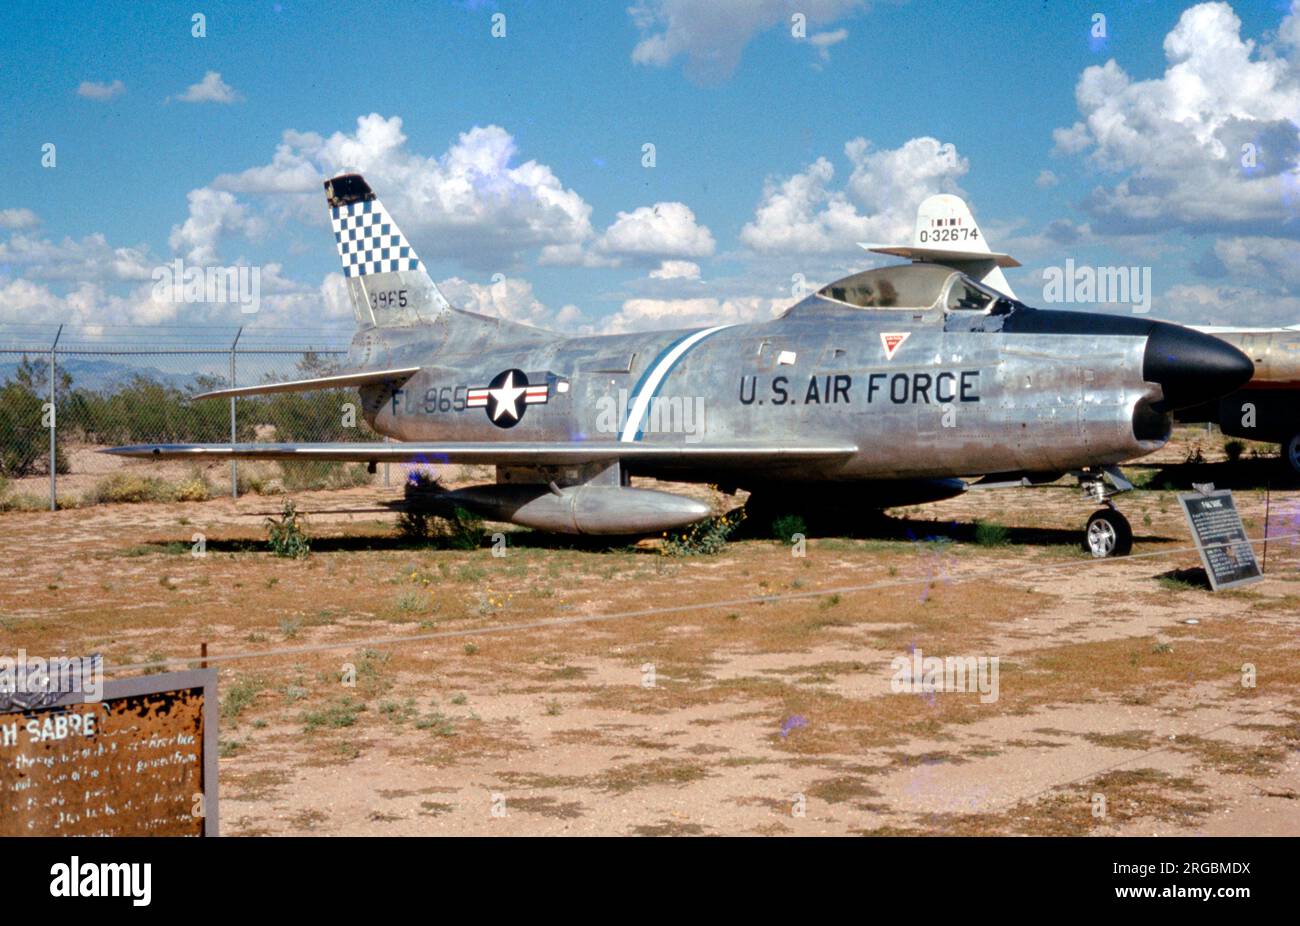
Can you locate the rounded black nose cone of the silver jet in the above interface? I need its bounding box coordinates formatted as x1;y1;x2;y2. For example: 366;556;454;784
1141;321;1255;412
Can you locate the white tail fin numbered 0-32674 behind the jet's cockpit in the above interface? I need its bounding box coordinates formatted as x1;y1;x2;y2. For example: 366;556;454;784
862;192;1021;299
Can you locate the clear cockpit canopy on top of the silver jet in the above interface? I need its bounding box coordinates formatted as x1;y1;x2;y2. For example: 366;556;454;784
818;264;1010;312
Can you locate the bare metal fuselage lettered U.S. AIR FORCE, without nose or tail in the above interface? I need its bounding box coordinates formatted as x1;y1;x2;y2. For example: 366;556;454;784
351;297;1167;486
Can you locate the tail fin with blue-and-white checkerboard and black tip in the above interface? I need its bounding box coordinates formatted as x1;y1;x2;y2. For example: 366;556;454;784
325;174;449;328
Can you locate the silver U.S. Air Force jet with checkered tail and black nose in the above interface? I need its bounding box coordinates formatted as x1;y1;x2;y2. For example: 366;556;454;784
109;174;1252;557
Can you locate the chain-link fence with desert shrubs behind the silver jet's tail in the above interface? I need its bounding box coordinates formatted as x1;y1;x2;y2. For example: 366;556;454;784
0;318;395;509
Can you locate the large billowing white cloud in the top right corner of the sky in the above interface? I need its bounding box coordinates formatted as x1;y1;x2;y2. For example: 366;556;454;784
1054;3;1300;233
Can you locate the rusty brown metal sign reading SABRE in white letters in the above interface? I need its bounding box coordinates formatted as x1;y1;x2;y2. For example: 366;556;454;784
0;668;217;836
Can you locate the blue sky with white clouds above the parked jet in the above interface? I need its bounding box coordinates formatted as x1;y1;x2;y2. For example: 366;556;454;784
0;0;1300;332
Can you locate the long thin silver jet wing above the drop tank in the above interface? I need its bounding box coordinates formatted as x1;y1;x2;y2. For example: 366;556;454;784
101;441;858;466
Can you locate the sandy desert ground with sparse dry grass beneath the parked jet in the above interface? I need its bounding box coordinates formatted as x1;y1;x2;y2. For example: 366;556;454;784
0;429;1300;836
